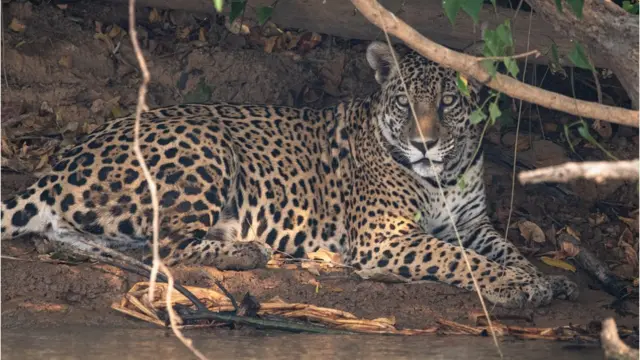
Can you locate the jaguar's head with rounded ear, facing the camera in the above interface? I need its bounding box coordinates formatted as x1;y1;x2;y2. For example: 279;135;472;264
367;42;481;179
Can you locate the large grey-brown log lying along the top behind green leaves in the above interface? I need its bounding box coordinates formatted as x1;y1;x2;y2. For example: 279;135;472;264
108;0;608;69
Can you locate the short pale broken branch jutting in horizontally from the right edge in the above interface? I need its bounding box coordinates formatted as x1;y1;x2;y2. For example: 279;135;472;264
518;159;640;184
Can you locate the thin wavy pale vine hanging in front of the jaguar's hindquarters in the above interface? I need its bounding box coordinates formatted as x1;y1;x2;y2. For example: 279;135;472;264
124;0;207;359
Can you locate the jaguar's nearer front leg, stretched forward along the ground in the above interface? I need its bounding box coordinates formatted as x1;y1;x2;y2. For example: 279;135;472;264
356;230;553;308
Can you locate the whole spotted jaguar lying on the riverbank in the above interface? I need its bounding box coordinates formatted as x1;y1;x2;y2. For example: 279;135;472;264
2;42;578;308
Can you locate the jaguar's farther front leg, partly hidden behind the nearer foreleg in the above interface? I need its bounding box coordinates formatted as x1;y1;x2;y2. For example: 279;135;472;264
453;219;579;300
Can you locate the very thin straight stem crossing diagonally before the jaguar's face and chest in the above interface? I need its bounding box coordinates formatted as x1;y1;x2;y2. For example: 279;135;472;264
381;22;504;359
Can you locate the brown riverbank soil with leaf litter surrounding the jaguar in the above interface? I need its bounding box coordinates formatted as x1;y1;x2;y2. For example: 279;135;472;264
1;1;638;334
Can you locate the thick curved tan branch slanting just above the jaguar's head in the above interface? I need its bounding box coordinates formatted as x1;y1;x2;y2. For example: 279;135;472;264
351;0;639;128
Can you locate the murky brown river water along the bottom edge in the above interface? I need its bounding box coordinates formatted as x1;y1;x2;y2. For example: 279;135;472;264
1;327;603;360
